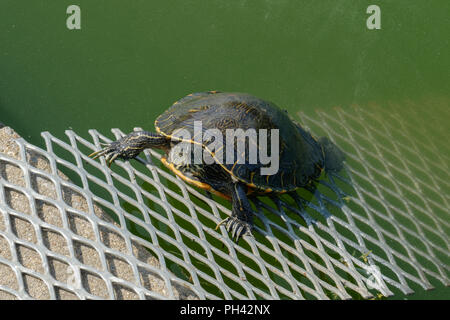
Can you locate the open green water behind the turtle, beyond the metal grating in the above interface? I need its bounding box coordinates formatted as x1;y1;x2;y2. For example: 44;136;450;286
0;0;450;298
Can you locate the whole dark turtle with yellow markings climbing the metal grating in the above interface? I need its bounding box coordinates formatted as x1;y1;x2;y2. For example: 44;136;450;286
89;91;345;241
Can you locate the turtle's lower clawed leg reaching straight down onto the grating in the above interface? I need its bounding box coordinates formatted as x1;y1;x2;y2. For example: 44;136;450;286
216;182;253;242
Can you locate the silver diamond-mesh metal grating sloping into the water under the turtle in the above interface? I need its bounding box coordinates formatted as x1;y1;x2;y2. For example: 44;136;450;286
0;103;450;299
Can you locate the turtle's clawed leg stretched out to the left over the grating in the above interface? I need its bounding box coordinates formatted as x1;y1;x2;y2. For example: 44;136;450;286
89;131;170;166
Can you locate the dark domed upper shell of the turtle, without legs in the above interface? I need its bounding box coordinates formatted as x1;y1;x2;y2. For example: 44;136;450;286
155;91;324;192
